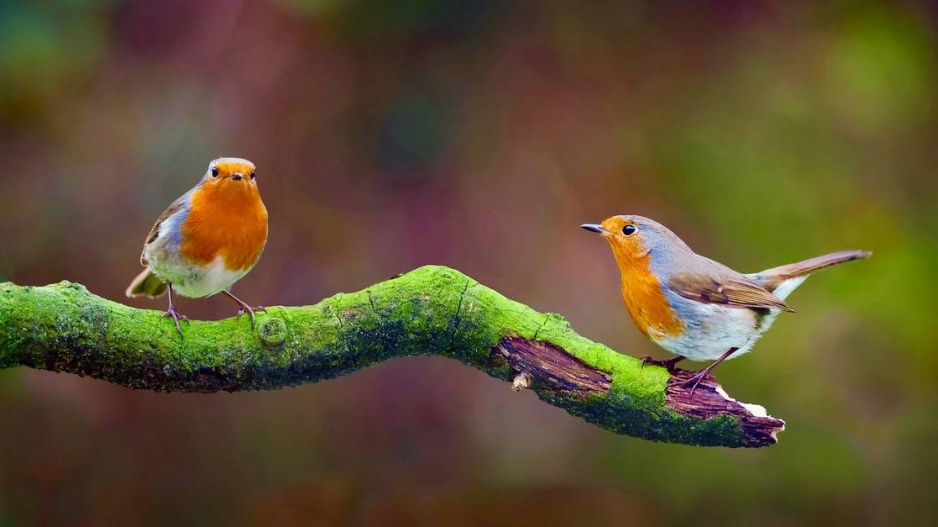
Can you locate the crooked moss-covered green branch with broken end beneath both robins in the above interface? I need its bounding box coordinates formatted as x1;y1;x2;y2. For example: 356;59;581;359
0;267;784;447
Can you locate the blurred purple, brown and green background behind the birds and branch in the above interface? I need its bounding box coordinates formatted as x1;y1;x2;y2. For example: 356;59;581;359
0;0;938;527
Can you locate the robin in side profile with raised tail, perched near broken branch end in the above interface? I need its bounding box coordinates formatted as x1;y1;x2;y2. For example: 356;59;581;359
581;215;871;393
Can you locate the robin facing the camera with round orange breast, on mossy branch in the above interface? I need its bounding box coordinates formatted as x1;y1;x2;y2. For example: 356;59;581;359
127;157;267;335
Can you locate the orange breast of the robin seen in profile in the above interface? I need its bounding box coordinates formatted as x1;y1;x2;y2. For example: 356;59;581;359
620;254;684;339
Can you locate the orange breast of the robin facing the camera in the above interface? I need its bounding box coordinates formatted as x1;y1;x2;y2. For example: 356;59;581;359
180;180;267;271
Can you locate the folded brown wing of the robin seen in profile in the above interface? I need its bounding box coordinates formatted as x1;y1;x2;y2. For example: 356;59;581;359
668;273;794;312
